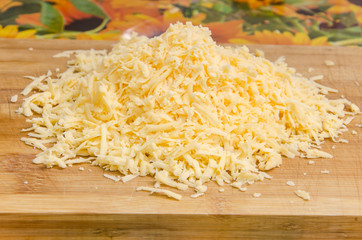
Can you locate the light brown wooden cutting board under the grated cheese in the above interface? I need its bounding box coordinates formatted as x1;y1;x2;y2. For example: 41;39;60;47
0;39;362;239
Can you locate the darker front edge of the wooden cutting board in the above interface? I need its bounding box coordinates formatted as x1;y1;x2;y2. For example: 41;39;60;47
0;214;362;239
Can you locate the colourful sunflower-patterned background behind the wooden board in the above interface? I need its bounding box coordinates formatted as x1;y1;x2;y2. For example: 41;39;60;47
0;0;362;46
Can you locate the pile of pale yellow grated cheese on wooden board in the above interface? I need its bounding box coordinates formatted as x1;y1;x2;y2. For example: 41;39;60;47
18;23;359;199
